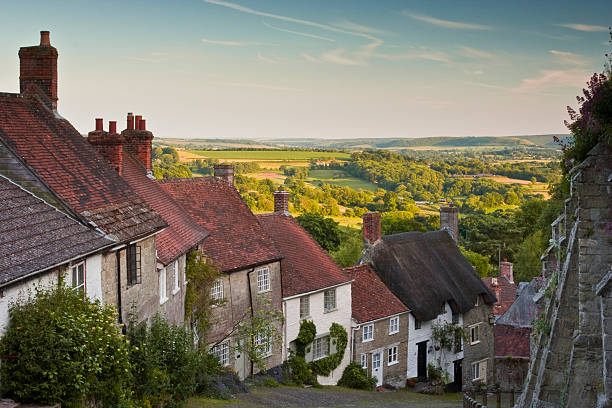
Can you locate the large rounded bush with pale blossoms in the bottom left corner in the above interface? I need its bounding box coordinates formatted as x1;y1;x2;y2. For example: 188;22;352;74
0;284;130;407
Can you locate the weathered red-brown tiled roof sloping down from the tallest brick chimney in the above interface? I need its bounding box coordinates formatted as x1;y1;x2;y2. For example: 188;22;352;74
0;93;166;242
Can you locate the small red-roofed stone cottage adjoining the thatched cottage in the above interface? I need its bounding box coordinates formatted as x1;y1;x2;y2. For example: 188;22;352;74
344;263;410;388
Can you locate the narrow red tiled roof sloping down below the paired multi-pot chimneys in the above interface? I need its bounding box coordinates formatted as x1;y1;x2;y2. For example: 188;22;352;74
121;151;208;265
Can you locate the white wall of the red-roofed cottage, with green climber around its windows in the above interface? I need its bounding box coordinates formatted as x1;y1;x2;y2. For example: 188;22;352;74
283;283;352;385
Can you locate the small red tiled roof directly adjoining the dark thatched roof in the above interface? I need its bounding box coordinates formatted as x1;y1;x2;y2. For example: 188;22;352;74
344;263;408;323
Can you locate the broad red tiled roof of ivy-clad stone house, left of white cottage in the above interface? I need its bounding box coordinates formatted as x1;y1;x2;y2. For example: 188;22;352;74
157;177;281;272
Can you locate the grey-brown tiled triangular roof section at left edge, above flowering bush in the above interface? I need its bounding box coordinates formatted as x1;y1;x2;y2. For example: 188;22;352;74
0;176;116;285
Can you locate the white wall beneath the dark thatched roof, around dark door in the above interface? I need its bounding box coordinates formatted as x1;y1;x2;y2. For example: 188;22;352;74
406;303;466;382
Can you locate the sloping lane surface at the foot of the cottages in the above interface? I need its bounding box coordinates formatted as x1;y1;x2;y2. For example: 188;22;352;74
187;387;462;408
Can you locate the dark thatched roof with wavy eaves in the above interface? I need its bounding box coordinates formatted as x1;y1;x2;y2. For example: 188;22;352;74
360;231;496;320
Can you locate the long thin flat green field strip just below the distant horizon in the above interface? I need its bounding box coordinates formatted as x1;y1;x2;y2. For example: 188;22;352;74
186;150;350;161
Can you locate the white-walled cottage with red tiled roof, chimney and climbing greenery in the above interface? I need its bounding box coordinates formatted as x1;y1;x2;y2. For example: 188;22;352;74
257;191;351;385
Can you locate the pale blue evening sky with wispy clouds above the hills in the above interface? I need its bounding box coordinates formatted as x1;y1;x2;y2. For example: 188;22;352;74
0;0;612;139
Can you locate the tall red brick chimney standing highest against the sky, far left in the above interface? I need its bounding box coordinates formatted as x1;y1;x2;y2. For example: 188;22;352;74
19;31;57;110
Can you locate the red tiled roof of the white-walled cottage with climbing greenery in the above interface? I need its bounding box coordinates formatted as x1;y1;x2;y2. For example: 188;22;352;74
257;212;350;297
